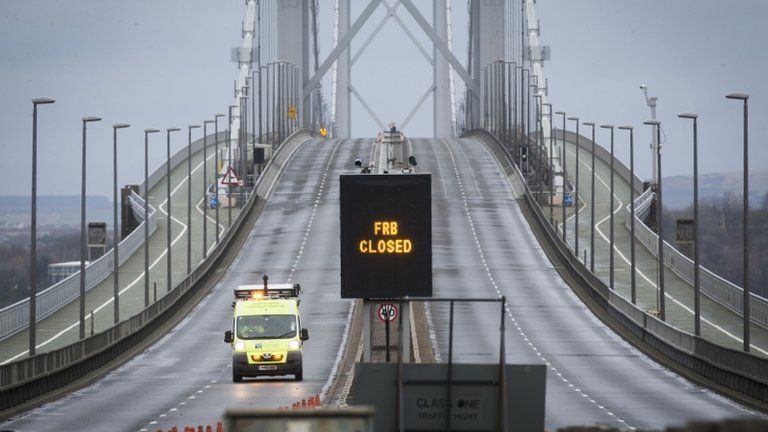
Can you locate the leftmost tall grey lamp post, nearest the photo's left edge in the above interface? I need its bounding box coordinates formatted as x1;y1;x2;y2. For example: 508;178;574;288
29;97;56;357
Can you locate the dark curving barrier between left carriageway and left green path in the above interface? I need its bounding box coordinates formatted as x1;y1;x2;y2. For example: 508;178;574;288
0;131;311;411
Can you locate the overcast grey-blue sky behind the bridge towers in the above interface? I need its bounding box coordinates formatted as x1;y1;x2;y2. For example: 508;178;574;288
0;0;768;196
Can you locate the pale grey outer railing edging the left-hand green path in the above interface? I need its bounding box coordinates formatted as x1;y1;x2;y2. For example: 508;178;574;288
0;192;157;341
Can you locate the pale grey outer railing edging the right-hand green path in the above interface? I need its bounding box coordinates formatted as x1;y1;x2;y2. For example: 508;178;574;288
624;185;768;327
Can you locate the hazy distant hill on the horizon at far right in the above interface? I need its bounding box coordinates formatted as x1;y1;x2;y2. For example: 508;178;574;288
664;170;768;209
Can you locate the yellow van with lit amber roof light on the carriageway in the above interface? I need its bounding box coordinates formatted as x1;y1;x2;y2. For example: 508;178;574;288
224;276;309;382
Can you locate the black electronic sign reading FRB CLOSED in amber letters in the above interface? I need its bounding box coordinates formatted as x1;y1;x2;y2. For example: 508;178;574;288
339;174;432;298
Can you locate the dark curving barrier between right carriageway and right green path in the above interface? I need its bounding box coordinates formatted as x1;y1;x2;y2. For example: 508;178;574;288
465;130;768;404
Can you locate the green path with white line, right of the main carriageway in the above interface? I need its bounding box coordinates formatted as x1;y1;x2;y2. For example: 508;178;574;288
544;141;768;356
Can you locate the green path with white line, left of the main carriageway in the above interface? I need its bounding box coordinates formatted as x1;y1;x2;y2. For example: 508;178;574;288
0;139;239;363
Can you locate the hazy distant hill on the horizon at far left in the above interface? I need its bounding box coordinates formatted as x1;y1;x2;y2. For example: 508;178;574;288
0;195;113;228
